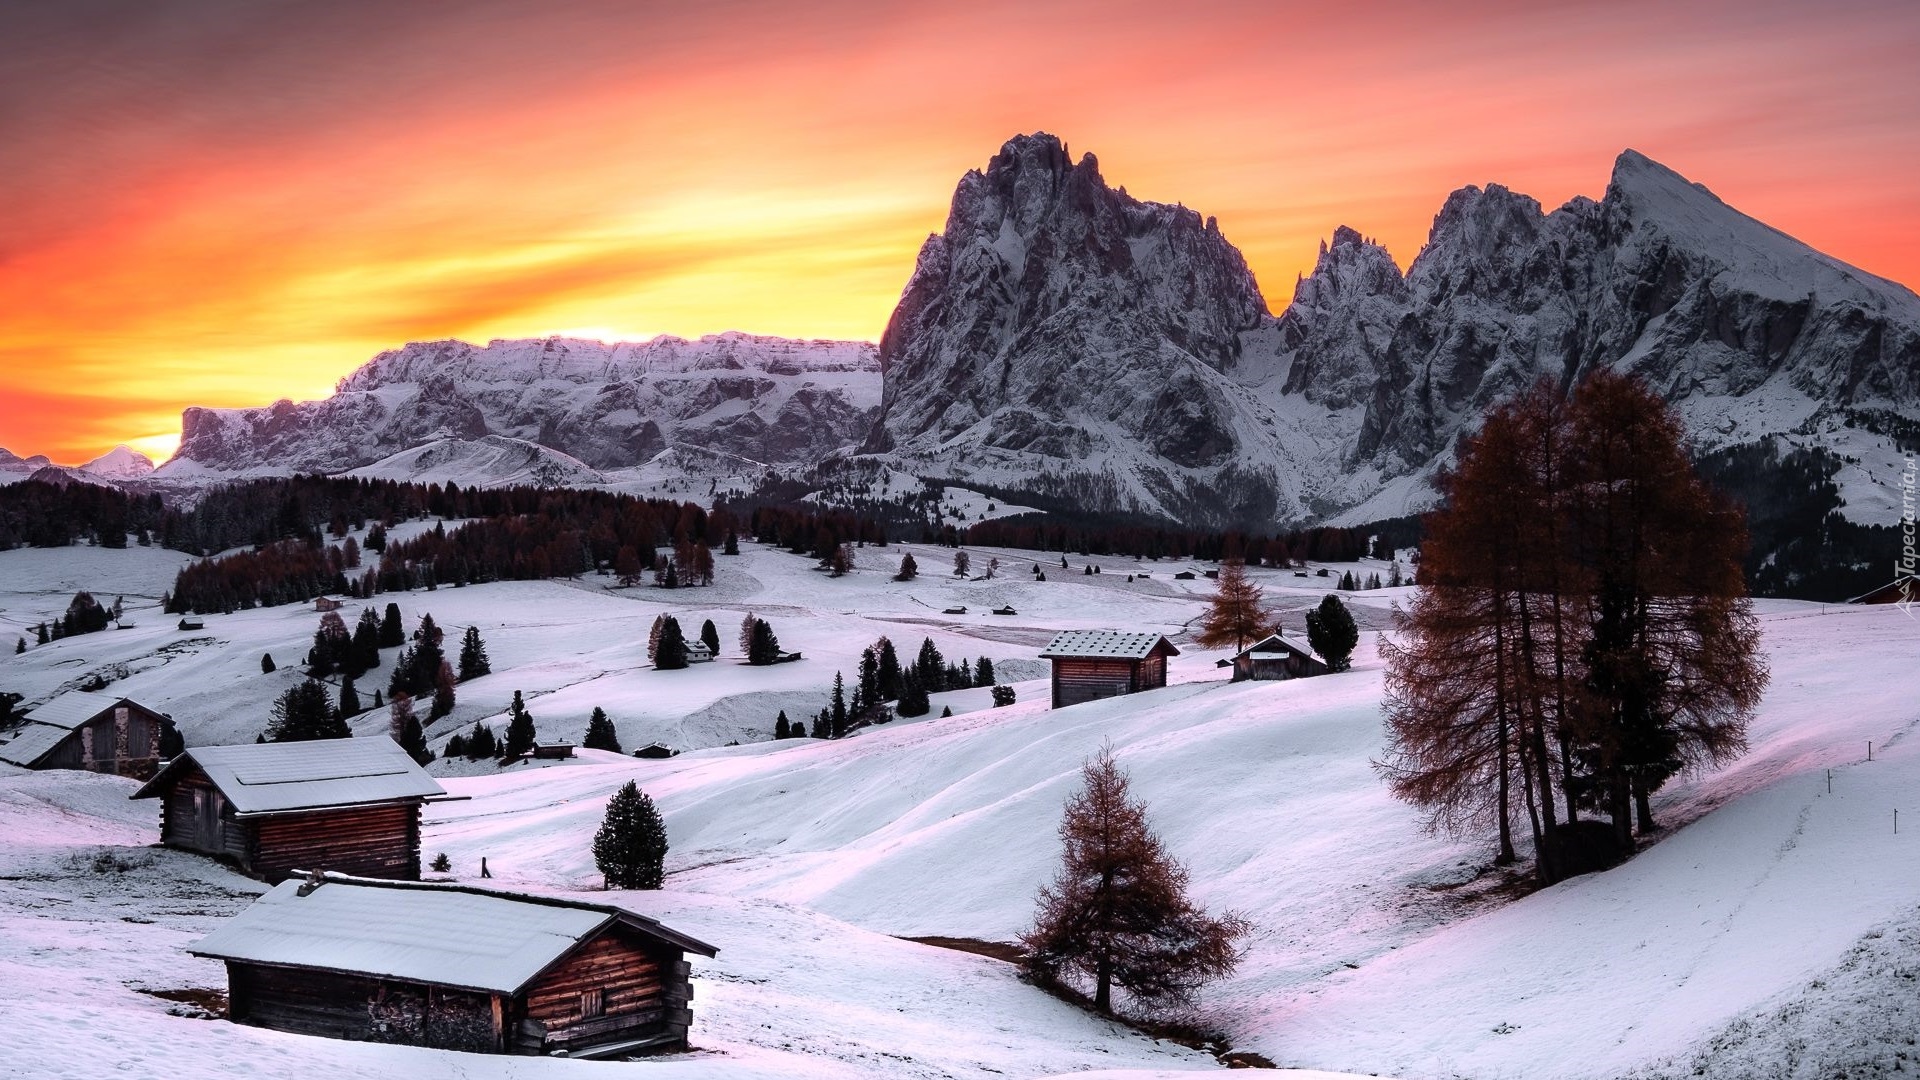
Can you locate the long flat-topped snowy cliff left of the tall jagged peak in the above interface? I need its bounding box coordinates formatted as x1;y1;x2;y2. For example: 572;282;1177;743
161;334;879;479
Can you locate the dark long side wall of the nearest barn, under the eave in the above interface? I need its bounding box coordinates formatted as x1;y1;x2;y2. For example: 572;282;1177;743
227;961;501;1053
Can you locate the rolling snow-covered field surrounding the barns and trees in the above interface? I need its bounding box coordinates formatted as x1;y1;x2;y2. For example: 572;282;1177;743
0;546;1920;1080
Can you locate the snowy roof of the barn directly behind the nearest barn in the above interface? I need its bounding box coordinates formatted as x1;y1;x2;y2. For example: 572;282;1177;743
132;736;447;813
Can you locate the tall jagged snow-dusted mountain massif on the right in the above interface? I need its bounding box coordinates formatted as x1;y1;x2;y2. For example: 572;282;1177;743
866;135;1920;525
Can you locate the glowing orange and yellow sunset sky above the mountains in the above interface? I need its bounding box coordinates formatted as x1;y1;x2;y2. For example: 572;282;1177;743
0;0;1920;461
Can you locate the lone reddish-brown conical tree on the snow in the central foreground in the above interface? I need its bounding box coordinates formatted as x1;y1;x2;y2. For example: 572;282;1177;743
1021;749;1252;1013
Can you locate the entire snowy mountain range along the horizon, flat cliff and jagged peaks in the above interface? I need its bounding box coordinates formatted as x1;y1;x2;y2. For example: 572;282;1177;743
18;135;1920;541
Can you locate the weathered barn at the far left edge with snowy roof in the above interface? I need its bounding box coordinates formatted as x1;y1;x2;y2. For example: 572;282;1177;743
0;690;177;780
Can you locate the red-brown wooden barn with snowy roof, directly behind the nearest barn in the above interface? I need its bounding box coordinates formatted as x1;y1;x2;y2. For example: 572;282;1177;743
132;736;447;882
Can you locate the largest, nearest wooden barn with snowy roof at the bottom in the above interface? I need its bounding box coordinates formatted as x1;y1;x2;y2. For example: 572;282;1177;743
188;872;718;1057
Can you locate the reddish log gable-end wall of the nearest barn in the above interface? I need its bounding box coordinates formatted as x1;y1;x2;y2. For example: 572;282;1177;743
515;926;693;1053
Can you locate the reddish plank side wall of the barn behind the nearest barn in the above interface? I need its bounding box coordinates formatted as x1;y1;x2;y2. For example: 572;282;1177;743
251;803;420;882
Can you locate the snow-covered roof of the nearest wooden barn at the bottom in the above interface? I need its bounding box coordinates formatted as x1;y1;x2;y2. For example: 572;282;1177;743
188;864;718;994
